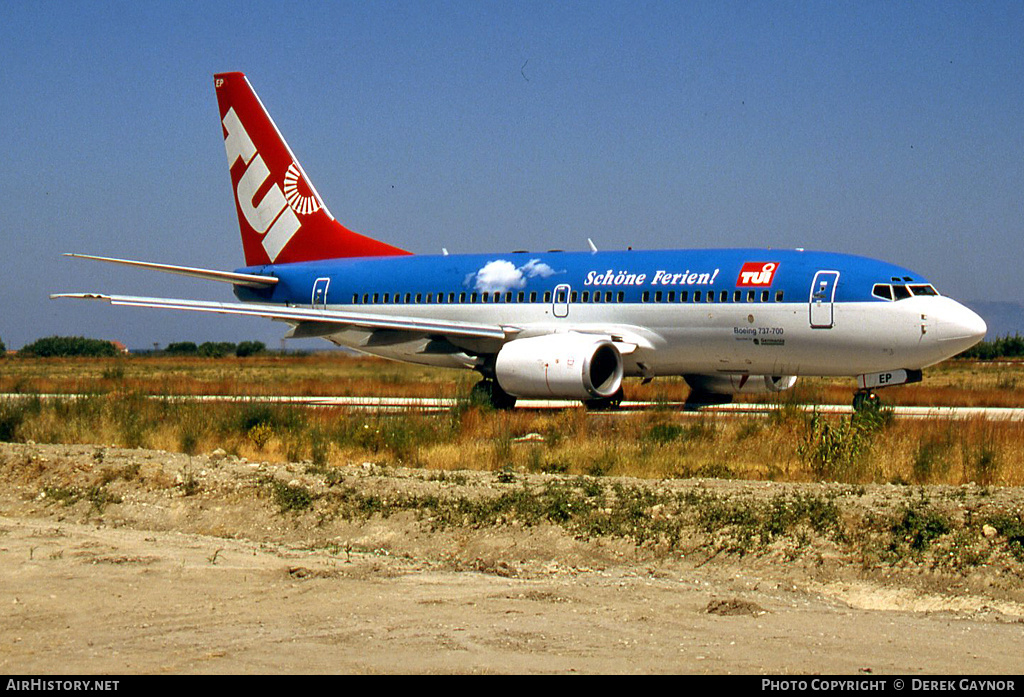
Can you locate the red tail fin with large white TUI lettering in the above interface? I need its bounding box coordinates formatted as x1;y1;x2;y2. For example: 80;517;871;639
213;73;409;266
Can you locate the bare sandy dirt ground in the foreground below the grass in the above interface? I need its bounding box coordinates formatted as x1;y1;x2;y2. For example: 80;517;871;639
0;443;1024;674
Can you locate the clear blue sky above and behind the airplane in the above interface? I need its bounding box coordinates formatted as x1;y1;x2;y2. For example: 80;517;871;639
0;1;1024;348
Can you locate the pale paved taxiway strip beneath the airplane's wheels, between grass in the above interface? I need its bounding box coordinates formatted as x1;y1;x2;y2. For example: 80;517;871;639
0;393;1024;422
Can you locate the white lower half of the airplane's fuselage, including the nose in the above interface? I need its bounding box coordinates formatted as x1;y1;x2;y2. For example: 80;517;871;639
311;297;977;377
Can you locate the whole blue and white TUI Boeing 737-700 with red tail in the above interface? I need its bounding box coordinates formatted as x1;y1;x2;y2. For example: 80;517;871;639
51;73;986;408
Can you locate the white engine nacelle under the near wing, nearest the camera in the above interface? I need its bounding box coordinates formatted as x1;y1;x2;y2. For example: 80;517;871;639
495;334;623;400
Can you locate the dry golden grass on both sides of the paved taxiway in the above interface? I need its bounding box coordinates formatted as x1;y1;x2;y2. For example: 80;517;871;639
0;353;1024;485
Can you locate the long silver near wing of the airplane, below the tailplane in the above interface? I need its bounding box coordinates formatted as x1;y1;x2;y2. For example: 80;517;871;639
50;293;512;341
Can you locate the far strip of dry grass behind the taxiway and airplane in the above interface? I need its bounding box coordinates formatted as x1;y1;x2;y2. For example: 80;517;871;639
0;352;1024;406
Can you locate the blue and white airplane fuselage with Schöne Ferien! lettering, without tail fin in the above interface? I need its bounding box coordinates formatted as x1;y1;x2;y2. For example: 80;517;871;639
236;249;984;376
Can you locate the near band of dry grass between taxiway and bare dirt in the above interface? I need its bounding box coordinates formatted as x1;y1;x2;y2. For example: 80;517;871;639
0;391;1024;486
